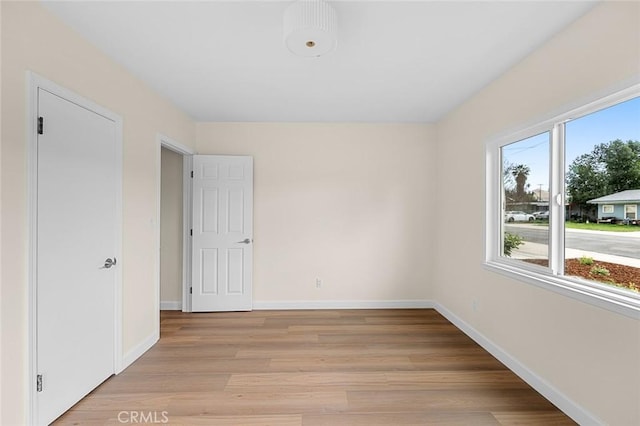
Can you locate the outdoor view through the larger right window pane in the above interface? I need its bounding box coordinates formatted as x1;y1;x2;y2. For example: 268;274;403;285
564;98;640;292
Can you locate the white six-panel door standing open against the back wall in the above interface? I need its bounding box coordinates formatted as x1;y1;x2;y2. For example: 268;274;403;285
191;155;253;312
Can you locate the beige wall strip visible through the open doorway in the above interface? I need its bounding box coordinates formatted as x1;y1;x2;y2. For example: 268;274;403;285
160;148;183;306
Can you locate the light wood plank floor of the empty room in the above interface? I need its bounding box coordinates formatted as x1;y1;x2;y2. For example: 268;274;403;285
56;309;575;426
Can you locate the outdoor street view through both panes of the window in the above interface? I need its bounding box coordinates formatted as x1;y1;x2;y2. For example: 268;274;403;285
500;97;640;294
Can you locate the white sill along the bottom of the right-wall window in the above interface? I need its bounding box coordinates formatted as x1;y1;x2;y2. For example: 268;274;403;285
484;260;640;319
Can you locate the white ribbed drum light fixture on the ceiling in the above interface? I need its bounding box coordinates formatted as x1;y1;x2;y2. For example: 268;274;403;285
284;0;338;57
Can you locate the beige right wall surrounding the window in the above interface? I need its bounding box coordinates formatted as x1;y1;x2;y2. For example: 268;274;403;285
432;2;640;425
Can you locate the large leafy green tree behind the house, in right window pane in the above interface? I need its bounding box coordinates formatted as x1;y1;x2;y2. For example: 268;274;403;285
566;139;640;209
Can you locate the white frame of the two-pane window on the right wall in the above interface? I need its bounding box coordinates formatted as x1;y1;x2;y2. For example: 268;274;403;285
483;83;640;319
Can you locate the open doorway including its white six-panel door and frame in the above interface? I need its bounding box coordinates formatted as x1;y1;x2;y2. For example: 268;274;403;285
158;146;253;312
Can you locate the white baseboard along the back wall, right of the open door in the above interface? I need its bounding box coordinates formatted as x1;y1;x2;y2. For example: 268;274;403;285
253;300;435;311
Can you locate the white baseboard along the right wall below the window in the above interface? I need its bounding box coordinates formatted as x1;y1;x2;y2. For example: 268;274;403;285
434;302;604;426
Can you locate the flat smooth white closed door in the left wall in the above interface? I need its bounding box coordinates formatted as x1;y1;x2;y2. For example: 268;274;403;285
36;88;120;424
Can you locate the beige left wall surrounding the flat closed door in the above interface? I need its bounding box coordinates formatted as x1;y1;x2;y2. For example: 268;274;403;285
0;2;194;425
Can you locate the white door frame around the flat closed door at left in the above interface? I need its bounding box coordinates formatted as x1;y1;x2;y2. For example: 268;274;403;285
25;71;123;424
